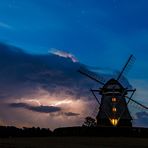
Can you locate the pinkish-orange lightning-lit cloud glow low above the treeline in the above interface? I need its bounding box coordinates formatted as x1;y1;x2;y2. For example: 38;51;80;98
3;86;91;129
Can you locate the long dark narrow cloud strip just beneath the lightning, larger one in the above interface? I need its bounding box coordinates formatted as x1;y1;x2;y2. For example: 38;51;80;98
10;103;61;113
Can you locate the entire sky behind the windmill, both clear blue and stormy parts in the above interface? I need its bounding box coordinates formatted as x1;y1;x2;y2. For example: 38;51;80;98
0;0;148;128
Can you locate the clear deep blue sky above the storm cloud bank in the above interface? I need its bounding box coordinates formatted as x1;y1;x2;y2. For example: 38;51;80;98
0;0;148;128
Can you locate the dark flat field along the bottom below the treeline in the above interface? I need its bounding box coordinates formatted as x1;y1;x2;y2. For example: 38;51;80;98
0;137;148;148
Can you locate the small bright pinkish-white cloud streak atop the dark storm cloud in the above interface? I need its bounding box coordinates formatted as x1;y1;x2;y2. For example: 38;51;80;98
49;48;78;62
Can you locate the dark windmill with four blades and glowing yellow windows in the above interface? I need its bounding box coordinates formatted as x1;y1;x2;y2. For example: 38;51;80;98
79;55;148;127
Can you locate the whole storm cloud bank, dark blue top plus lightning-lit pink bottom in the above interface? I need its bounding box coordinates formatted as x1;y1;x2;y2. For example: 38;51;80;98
0;43;146;129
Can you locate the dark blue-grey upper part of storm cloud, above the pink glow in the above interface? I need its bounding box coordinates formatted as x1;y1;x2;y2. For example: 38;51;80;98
0;44;96;99
